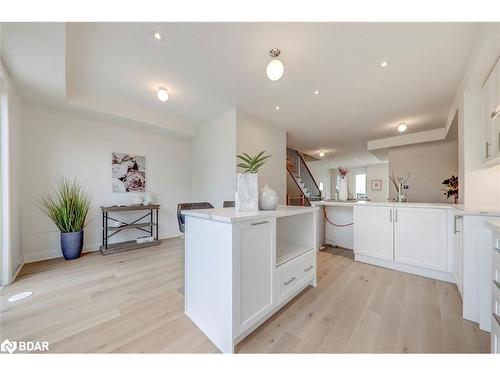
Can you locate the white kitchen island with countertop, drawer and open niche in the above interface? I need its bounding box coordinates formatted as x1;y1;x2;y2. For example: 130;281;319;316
182;206;318;353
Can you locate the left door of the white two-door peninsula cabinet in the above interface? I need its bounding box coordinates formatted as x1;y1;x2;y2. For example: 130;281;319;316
353;206;393;260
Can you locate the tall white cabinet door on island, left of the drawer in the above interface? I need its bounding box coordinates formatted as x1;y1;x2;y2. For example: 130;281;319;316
233;219;276;337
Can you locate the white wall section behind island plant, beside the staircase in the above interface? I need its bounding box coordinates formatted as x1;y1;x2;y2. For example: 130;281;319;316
236;111;288;204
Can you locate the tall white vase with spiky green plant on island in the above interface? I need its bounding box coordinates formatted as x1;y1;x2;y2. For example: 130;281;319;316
236;151;271;211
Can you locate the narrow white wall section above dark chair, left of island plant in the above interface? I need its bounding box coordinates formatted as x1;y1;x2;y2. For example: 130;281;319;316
190;110;236;207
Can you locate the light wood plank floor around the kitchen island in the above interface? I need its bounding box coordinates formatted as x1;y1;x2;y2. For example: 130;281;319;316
0;239;489;353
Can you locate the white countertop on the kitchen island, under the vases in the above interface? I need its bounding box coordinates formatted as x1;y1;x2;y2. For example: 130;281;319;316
181;206;319;223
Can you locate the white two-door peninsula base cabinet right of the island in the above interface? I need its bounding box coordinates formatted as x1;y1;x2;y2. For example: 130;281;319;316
354;205;455;282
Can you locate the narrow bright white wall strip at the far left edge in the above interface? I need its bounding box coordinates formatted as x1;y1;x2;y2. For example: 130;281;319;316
0;62;24;284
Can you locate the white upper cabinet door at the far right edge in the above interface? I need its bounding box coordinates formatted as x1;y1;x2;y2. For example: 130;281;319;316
482;73;494;162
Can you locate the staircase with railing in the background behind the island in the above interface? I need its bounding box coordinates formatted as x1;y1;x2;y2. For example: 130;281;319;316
286;148;322;206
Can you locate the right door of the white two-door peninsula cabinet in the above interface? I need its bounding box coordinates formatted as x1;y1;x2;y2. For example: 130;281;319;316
394;207;447;271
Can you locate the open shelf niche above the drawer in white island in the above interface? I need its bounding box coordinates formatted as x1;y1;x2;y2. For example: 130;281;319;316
276;213;314;266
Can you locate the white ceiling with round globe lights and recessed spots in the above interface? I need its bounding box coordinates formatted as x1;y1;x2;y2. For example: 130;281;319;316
2;23;477;164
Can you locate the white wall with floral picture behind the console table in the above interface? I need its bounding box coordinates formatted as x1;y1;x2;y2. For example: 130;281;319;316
18;103;190;261
